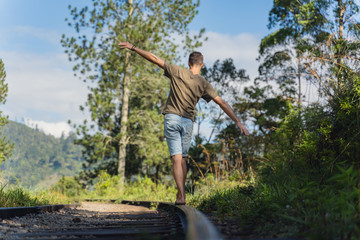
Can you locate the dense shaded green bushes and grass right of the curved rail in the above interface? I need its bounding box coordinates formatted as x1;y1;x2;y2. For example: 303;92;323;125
191;98;360;239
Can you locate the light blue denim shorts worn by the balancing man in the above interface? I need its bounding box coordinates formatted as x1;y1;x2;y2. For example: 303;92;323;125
164;113;193;157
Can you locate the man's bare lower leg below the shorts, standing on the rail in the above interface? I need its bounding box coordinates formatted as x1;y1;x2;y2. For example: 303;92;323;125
171;154;186;203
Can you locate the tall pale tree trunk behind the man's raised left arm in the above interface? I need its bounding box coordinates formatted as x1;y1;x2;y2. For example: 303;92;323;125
118;0;133;185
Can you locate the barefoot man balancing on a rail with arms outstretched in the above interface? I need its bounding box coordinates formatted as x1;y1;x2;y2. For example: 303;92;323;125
119;42;249;205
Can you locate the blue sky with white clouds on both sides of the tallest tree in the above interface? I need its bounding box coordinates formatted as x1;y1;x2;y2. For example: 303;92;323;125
0;0;272;135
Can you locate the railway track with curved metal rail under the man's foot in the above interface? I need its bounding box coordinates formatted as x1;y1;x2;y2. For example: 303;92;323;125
0;201;221;240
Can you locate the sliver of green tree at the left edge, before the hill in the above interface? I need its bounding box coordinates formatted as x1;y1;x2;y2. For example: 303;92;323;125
0;59;13;165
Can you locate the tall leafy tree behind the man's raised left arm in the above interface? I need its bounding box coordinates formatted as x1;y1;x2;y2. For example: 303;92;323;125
62;0;204;184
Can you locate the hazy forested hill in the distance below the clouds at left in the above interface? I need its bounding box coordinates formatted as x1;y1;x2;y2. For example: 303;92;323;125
0;121;82;188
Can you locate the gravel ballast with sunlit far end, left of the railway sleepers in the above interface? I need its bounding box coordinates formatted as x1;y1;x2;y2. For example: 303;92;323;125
0;202;157;239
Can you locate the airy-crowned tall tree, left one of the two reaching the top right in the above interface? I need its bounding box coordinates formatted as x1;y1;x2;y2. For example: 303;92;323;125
258;0;329;105
